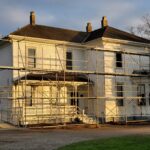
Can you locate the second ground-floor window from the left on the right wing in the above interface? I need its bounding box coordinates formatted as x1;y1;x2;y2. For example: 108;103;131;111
137;84;146;106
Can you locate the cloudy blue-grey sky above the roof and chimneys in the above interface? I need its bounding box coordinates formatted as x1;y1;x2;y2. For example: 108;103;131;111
0;0;150;35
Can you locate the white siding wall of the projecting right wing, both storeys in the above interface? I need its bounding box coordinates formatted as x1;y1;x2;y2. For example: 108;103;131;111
103;42;150;121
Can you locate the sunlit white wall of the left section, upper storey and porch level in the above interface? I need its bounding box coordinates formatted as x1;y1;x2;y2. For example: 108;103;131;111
13;41;98;123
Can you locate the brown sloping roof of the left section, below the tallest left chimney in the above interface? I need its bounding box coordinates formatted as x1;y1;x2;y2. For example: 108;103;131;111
10;25;87;43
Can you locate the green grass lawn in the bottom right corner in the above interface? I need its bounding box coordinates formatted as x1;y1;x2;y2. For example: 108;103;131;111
58;135;150;150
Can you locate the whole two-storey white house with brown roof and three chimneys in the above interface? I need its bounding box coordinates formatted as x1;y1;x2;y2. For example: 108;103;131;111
0;12;150;125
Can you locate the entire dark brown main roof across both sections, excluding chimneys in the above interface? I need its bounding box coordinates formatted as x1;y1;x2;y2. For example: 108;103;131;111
10;24;150;43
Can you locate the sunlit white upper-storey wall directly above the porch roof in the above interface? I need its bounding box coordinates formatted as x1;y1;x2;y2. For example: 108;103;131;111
13;41;87;78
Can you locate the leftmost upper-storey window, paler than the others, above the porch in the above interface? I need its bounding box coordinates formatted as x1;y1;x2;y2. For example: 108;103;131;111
28;48;36;68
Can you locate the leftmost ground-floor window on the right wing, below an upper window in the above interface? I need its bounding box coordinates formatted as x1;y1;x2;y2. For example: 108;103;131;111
116;83;123;106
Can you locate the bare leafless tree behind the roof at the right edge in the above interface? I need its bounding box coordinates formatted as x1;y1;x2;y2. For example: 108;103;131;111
129;14;150;39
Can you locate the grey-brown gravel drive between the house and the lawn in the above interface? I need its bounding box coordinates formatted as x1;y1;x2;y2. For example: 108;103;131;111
0;126;150;150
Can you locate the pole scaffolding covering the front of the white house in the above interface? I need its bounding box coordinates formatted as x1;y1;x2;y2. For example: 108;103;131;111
0;38;150;126
